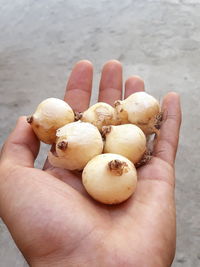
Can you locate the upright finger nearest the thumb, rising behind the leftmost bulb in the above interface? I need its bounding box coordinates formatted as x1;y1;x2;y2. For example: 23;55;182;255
64;60;93;112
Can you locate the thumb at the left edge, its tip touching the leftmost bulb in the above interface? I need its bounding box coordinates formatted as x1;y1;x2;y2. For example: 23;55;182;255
0;116;39;167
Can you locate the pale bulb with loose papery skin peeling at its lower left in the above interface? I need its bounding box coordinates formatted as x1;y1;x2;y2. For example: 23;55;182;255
48;121;103;170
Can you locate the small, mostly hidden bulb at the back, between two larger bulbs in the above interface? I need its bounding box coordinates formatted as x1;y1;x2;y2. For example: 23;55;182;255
81;102;118;131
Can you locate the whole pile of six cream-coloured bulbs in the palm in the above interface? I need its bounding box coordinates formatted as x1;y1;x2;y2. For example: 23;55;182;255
27;92;161;204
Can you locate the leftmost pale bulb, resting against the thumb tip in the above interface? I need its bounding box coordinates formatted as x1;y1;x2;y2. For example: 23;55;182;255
27;98;74;144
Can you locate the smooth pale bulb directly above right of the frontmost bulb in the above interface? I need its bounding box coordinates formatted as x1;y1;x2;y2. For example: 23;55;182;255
102;124;146;164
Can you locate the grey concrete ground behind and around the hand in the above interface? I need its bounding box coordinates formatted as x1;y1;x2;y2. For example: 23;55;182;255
0;0;200;267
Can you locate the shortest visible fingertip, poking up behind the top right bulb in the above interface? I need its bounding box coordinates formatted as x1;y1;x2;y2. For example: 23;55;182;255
124;76;145;98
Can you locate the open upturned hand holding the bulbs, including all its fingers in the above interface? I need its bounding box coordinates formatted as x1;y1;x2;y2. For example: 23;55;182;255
0;61;181;267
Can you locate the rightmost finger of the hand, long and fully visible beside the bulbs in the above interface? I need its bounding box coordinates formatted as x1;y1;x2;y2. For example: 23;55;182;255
154;93;181;165
